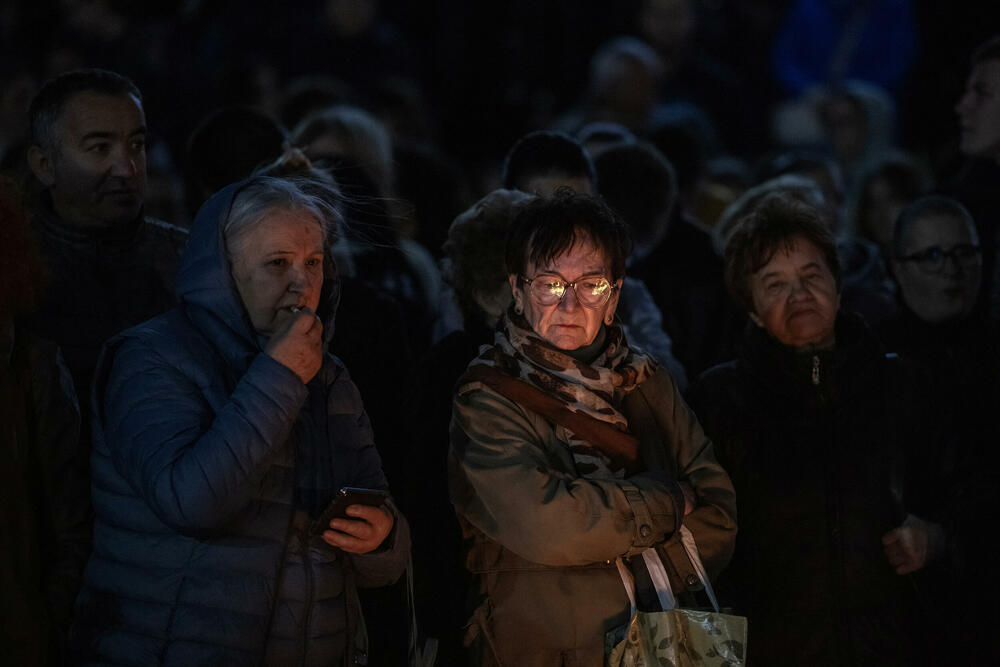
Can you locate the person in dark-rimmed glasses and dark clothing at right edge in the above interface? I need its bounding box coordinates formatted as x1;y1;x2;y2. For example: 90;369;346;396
882;190;1000;665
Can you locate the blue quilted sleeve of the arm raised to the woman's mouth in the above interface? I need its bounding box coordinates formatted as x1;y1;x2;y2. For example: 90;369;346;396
102;340;307;536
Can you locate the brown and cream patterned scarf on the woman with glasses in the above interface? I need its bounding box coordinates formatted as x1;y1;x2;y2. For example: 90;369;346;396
470;308;656;479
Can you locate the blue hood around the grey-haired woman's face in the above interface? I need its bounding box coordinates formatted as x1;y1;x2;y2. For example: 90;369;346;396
174;181;340;362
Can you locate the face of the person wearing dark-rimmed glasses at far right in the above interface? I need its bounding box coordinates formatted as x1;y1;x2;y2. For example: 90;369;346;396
892;215;983;324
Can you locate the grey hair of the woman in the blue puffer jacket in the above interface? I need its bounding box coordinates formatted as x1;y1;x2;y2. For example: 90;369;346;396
222;176;341;260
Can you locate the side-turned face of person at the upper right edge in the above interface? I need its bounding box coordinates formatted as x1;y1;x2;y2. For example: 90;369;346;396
955;60;1000;162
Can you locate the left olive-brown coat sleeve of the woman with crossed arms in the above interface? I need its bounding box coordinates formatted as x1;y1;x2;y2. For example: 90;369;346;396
449;387;684;566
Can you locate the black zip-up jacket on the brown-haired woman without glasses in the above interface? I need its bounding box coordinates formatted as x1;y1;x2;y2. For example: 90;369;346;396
690;313;936;667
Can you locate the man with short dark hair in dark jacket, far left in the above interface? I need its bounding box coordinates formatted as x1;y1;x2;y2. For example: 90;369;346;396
28;69;187;418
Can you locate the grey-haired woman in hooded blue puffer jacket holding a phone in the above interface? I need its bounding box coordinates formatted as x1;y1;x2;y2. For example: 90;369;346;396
72;177;409;666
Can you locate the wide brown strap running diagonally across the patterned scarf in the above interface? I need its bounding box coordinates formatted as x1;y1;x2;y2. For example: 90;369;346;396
458;364;639;472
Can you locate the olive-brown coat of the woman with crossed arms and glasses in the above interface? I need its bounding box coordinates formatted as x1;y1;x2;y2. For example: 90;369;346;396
449;371;736;667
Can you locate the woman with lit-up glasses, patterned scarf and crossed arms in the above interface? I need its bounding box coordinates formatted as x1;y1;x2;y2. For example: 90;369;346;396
449;193;736;667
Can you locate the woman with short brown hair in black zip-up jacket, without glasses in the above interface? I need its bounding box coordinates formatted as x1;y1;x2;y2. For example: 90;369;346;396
689;194;946;667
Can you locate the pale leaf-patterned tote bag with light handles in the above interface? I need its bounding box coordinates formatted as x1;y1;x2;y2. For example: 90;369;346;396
605;527;747;667
